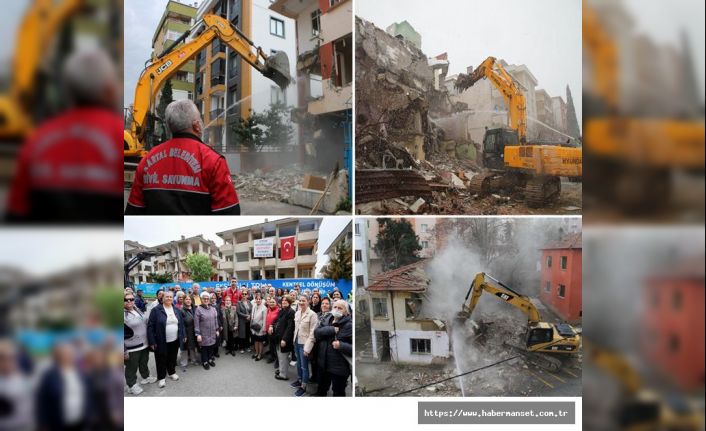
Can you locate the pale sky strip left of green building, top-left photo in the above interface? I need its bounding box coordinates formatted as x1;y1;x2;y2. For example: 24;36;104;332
123;0;170;107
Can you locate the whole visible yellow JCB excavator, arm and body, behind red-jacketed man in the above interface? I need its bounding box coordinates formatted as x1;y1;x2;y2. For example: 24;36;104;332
123;14;291;168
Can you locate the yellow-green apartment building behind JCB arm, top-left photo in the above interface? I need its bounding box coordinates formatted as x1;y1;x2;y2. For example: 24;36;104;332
152;0;196;106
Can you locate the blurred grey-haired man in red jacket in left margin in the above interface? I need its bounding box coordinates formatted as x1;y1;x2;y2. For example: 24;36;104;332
7;49;123;223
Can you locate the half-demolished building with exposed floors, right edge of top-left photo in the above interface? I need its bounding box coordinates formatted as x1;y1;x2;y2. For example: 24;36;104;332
270;0;353;176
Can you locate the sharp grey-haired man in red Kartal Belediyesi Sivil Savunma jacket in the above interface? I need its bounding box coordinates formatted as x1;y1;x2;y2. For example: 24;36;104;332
125;100;240;215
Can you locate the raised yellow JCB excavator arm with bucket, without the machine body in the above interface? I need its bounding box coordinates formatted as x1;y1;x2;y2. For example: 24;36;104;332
130;14;290;147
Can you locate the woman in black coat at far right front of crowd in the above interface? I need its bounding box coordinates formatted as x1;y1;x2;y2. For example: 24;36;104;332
314;299;353;397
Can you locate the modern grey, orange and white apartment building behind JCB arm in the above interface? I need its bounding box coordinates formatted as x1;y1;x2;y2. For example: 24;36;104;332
194;0;296;154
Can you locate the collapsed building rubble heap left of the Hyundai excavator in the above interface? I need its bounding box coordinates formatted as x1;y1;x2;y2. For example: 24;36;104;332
356;18;526;214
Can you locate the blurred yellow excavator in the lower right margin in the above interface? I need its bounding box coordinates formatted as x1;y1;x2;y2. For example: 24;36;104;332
584;341;703;431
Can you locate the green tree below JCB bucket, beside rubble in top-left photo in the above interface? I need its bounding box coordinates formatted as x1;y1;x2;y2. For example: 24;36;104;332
232;103;294;151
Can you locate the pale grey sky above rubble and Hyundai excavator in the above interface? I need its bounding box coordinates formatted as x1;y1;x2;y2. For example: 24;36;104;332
356;0;582;122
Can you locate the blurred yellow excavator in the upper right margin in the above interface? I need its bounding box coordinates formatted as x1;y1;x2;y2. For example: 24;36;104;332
582;1;704;211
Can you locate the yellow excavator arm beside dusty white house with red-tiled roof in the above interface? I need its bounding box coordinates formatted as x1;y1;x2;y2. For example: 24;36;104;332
459;272;541;325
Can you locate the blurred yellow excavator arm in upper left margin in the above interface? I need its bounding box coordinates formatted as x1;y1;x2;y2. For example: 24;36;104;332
0;0;86;142
